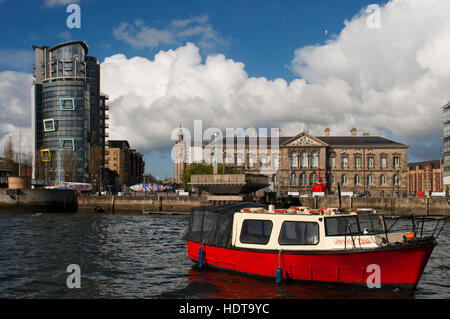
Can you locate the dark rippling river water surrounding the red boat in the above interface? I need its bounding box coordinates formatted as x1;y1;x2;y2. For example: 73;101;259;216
0;214;450;299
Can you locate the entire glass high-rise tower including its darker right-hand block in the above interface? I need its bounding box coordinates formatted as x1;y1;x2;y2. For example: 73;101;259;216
31;41;108;184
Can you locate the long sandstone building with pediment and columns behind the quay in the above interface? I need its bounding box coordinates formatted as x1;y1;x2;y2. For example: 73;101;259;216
175;128;408;196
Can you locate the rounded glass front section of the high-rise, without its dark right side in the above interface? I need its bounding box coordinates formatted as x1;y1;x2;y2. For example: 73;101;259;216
34;41;95;184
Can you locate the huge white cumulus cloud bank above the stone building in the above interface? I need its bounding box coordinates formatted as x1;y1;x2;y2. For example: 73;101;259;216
101;0;450;165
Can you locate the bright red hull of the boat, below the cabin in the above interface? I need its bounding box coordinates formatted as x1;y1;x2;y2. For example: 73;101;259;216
187;239;435;289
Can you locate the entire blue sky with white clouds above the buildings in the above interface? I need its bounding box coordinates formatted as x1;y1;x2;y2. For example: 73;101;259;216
0;0;450;177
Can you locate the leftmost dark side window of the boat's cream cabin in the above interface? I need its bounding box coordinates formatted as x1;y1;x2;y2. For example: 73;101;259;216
239;219;272;245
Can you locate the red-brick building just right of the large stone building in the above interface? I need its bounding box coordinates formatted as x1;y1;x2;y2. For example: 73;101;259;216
408;160;444;196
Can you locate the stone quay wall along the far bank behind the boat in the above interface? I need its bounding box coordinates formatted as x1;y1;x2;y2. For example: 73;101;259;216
78;195;450;216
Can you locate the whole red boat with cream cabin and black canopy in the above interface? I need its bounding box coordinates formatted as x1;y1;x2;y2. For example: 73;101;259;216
185;203;446;289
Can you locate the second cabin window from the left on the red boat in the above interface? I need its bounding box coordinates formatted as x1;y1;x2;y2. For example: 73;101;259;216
278;221;319;245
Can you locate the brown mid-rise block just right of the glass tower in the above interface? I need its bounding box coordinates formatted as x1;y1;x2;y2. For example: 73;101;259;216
105;140;145;187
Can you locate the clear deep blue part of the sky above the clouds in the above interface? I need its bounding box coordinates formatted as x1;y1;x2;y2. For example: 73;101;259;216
0;0;384;80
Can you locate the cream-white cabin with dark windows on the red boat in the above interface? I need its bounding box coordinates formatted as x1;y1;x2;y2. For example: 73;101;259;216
231;205;405;251
